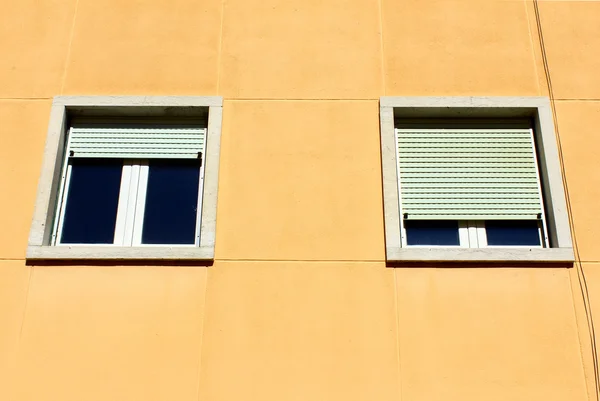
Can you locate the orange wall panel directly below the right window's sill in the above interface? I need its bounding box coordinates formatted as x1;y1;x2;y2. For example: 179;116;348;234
395;266;587;401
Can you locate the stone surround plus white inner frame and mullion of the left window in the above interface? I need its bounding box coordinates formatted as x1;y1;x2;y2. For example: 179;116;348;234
27;96;223;261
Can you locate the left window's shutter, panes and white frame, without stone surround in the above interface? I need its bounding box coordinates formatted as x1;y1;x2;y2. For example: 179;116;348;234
52;123;206;246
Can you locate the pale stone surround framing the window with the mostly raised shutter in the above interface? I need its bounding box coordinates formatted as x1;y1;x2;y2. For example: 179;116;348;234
26;96;223;262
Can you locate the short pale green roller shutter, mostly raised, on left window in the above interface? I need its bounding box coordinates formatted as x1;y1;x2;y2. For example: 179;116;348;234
67;127;206;159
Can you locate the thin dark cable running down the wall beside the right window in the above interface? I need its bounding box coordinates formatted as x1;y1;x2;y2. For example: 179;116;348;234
533;0;600;401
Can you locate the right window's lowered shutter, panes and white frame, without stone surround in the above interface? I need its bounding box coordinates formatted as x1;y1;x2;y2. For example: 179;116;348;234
395;126;548;248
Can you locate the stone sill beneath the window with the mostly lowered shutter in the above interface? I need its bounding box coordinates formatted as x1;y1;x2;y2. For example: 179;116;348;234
386;248;575;264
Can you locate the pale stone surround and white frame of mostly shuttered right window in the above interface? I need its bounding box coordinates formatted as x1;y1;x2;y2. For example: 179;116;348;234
380;97;574;264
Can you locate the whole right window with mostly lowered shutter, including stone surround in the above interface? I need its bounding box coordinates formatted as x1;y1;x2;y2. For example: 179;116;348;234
381;98;573;263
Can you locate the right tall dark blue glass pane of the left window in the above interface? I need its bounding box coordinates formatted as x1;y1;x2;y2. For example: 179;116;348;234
142;160;200;244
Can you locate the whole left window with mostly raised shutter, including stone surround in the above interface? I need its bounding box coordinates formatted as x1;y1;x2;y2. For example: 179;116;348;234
27;96;222;260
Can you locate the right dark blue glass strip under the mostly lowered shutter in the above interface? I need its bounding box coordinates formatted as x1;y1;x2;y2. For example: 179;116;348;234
485;220;540;246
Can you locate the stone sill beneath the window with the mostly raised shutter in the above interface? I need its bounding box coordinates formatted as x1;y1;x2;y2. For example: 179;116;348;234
27;246;215;261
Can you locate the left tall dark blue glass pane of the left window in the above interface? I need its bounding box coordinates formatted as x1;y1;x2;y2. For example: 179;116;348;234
60;159;123;244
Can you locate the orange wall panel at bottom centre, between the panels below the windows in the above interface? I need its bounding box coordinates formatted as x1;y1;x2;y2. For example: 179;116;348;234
199;262;398;401
